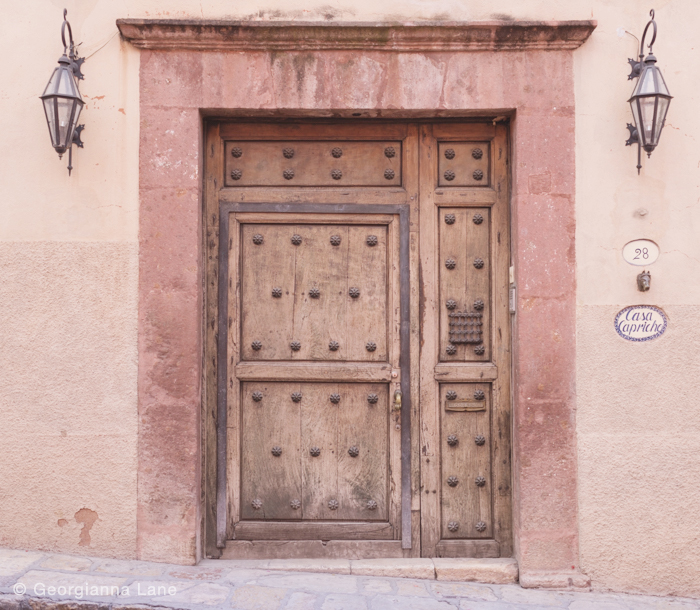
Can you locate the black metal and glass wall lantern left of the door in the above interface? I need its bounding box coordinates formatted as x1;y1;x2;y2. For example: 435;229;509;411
40;9;85;176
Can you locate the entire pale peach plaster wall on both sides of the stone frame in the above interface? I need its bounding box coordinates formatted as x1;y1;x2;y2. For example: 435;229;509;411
0;0;700;595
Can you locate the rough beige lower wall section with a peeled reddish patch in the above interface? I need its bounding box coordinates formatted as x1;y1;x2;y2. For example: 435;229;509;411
0;242;138;557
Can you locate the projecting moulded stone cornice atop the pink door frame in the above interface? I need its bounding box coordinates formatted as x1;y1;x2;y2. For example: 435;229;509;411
117;19;596;52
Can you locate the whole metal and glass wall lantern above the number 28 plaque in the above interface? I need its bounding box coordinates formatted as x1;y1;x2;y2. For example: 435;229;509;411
625;9;671;174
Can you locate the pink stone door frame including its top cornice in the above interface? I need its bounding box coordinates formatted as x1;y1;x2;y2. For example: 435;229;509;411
117;19;596;586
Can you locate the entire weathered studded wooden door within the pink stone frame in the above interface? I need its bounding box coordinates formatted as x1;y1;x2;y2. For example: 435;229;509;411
205;122;511;558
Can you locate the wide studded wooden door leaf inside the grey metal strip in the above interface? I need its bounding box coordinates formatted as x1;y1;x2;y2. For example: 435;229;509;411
228;213;401;540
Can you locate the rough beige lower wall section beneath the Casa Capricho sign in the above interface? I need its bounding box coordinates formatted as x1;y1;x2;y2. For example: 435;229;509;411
577;304;700;596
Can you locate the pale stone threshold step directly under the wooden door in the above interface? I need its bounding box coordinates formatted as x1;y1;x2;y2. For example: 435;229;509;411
197;558;518;585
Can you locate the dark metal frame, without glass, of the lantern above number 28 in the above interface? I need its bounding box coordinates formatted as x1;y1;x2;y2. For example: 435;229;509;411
625;9;673;174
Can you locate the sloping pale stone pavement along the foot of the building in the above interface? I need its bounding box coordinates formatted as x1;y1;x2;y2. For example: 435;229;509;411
0;549;700;610
